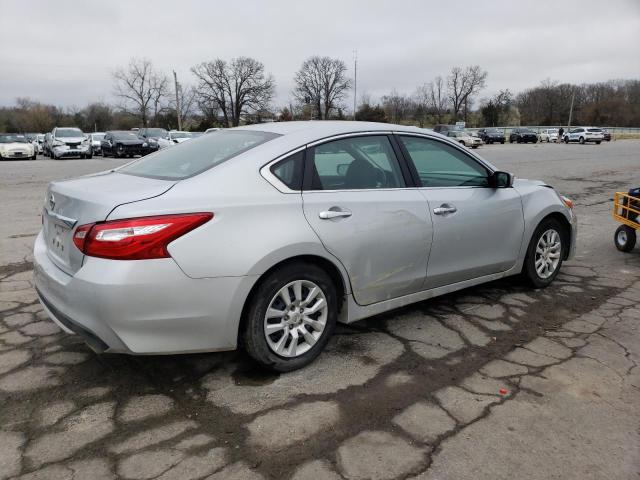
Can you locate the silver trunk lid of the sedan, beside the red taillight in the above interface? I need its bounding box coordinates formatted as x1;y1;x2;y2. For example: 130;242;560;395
42;172;176;275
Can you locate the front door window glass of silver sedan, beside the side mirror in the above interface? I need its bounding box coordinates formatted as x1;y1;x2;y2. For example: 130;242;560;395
399;136;489;187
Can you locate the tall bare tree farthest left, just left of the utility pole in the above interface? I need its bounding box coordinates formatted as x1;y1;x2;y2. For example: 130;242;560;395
113;58;169;126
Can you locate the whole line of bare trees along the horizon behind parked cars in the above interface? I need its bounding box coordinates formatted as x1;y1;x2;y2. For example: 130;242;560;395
0;56;640;132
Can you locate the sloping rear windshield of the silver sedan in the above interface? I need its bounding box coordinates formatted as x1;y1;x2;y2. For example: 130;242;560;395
118;130;280;180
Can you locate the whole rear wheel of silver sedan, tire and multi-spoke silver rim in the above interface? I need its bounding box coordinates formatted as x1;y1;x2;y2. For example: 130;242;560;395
242;263;338;372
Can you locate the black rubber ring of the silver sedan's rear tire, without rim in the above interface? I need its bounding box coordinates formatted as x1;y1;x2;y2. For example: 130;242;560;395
242;263;338;372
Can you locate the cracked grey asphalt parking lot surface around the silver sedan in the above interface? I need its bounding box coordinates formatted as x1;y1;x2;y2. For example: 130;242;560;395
0;140;640;480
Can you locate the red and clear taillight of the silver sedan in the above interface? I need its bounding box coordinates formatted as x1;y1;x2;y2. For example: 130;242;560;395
73;213;213;260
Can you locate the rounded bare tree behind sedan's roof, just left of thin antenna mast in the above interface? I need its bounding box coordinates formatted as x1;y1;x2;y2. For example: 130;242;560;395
293;56;351;120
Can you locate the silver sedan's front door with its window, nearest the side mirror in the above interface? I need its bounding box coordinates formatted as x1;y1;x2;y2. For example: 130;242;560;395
398;135;524;289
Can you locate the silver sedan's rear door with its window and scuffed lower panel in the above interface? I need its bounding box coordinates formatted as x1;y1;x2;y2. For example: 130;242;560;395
302;135;432;305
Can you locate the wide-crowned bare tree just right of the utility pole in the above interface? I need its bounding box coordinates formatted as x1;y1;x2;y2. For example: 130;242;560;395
191;57;275;127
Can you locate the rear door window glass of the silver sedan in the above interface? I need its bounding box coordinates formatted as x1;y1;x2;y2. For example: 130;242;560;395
309;135;405;190
